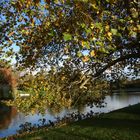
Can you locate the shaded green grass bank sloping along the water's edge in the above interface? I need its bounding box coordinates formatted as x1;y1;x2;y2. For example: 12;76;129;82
7;103;140;140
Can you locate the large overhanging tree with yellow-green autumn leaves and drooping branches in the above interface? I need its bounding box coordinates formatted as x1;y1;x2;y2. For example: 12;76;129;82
0;0;140;111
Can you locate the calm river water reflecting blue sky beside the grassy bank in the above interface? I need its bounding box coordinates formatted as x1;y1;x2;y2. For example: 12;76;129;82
0;92;140;138
